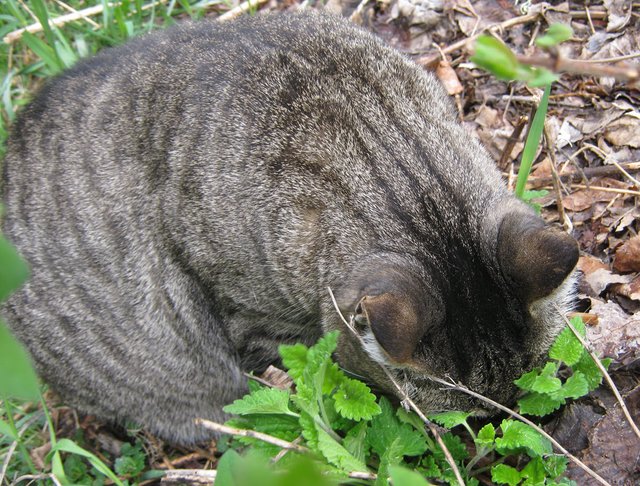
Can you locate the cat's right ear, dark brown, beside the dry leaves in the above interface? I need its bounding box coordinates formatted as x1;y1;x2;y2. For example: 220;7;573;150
498;212;579;303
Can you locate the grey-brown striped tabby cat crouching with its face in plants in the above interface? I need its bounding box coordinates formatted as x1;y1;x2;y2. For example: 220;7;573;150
3;11;578;444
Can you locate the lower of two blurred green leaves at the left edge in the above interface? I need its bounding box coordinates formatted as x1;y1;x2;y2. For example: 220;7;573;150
0;321;40;400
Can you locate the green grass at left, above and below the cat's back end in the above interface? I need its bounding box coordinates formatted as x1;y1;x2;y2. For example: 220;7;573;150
0;0;235;485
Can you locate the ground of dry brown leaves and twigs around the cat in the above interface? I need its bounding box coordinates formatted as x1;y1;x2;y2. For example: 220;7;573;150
0;0;640;485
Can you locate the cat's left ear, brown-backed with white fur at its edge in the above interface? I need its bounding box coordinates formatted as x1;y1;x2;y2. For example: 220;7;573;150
356;292;427;363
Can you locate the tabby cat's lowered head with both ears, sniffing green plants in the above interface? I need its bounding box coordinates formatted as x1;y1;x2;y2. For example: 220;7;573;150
336;211;578;413
